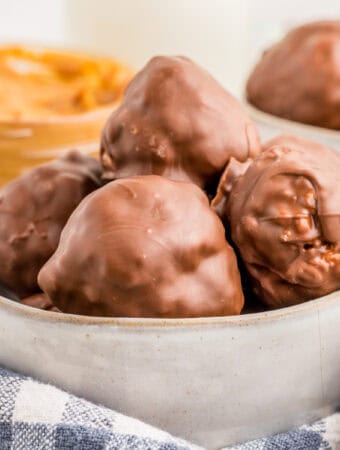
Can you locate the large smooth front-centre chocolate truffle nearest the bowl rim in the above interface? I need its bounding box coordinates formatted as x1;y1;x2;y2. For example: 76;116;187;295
39;175;243;318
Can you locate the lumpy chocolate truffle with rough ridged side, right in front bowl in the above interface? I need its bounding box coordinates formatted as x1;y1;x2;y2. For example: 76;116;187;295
224;136;340;307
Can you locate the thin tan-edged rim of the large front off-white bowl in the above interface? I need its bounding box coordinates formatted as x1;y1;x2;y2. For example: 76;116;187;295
0;290;340;328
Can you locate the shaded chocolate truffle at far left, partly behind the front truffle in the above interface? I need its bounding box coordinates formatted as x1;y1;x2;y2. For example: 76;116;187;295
0;152;101;298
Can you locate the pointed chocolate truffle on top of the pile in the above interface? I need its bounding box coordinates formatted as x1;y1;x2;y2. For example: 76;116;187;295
101;56;260;190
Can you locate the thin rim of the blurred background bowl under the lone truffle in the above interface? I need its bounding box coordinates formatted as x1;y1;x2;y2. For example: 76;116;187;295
243;100;340;142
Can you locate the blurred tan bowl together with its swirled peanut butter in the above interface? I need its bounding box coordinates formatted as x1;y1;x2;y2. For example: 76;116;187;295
0;46;132;185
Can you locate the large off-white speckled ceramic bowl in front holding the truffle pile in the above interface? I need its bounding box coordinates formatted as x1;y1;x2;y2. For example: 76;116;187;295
0;291;340;449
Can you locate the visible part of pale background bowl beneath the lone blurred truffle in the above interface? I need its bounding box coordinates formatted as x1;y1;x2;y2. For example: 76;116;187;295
244;100;340;152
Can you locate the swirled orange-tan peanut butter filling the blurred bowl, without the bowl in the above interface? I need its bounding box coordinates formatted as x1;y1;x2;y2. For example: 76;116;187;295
0;47;130;121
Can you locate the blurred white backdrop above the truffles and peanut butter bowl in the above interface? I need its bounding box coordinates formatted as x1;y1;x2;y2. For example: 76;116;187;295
0;0;340;96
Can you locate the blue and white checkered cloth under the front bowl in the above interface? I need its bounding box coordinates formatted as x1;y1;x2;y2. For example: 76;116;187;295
0;369;340;450
